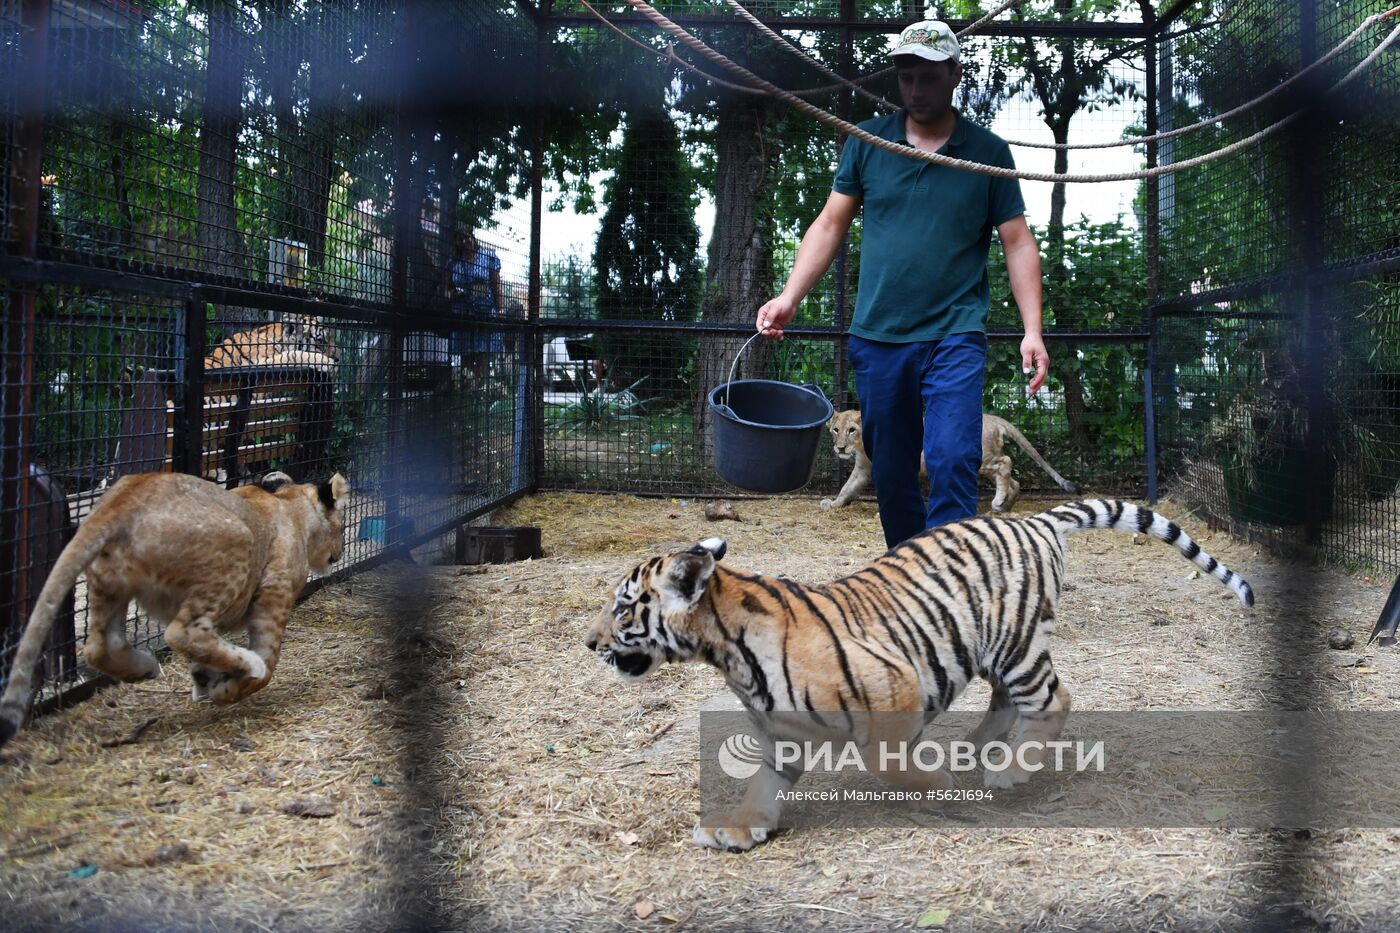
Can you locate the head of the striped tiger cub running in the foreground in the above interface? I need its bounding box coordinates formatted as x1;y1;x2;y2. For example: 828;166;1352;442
585;538;728;681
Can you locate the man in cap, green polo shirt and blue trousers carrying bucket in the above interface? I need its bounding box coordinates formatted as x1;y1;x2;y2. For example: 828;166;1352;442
756;22;1050;546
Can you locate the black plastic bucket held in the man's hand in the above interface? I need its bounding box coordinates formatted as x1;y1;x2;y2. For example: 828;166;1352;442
710;380;833;493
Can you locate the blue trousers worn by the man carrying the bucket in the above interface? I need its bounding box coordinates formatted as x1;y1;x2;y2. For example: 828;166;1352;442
847;333;987;548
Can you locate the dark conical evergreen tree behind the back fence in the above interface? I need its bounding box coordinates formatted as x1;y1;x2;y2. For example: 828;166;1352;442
594;106;701;399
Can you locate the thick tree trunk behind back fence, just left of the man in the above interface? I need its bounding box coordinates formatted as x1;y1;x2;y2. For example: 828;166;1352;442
694;94;773;459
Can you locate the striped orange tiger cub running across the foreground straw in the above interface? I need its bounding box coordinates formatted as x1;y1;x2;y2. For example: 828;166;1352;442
587;500;1254;850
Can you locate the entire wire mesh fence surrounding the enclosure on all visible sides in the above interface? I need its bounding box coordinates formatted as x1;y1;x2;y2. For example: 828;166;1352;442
0;0;1400;918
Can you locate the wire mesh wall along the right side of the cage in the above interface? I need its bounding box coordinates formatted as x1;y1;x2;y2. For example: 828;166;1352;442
1155;3;1400;573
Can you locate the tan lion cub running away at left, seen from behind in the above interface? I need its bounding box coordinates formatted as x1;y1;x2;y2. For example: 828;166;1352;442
0;474;350;745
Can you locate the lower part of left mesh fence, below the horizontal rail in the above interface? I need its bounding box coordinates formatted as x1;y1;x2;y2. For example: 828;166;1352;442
0;275;531;706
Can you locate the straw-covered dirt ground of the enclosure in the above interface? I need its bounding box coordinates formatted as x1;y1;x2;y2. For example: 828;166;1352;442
0;495;1400;930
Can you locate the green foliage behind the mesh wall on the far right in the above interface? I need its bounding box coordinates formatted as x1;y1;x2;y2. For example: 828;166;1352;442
1161;1;1400;496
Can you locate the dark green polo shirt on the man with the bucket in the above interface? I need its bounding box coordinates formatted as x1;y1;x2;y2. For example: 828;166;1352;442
832;109;1026;343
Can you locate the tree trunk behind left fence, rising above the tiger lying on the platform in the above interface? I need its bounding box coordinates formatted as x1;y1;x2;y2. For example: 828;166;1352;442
197;0;259;328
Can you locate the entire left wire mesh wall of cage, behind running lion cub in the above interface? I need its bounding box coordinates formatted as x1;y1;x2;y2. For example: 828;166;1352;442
0;1;538;708
